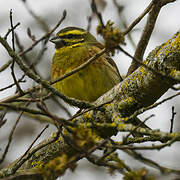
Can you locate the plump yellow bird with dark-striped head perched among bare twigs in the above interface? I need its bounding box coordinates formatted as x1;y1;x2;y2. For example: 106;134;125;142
50;27;121;102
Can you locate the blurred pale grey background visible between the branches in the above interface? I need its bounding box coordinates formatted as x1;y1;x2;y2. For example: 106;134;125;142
0;0;180;180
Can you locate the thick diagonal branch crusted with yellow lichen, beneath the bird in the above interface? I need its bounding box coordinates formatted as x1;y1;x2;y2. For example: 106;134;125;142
0;33;180;177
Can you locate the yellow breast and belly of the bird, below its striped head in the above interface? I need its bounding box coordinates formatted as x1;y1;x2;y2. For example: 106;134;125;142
51;43;120;102
